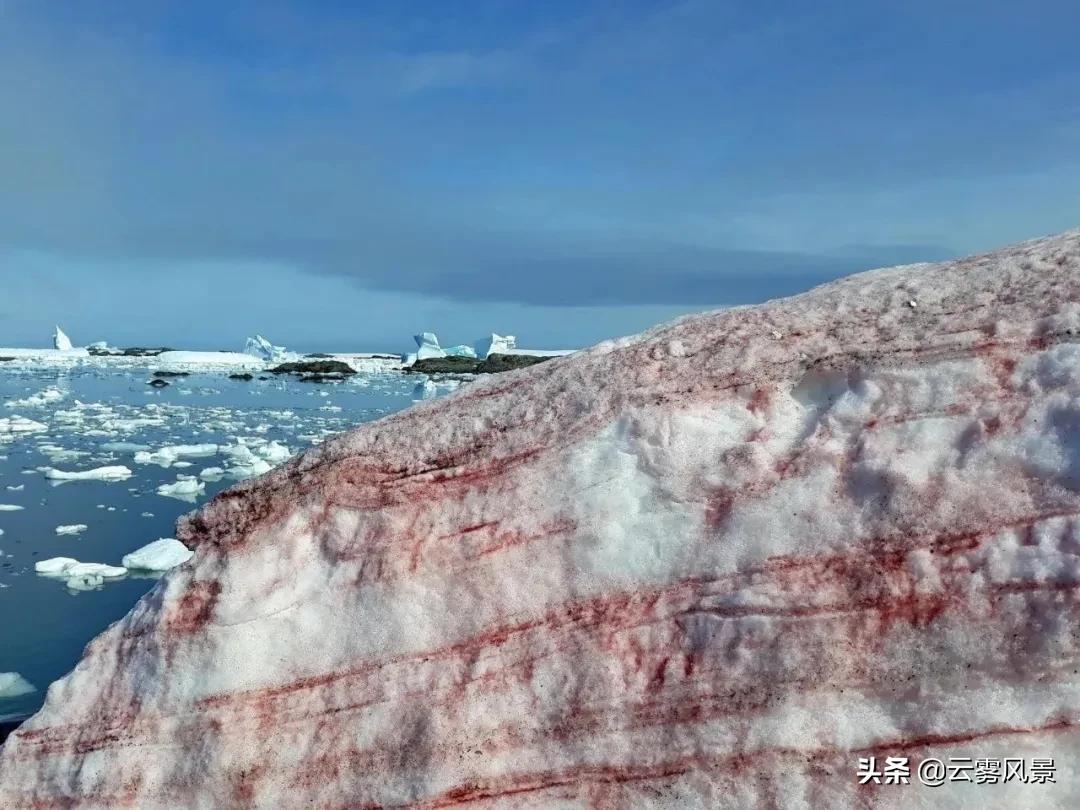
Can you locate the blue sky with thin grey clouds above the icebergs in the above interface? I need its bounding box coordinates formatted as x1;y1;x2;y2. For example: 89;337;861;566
0;0;1080;350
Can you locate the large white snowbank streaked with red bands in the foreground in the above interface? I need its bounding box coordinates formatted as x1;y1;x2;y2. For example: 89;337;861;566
0;232;1080;808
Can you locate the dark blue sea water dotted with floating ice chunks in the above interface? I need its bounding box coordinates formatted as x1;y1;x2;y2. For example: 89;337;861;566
0;367;431;719
